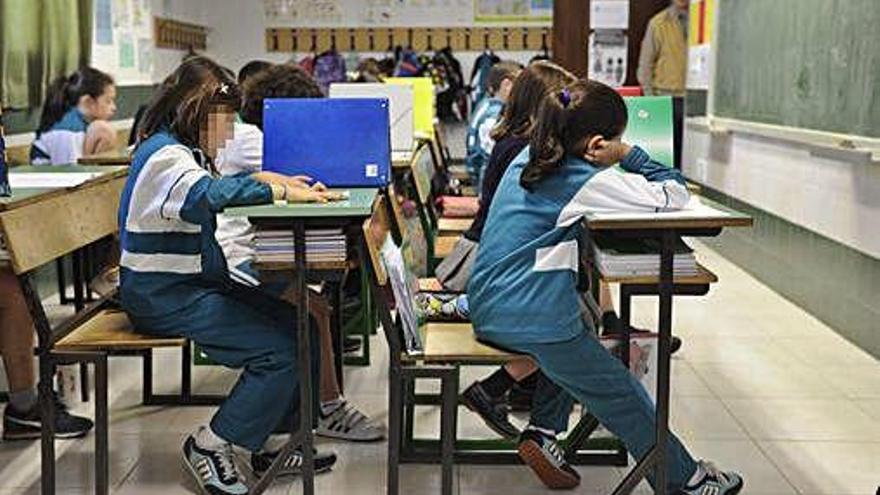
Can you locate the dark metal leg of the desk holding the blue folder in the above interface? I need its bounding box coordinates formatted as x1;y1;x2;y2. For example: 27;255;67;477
291;222;315;495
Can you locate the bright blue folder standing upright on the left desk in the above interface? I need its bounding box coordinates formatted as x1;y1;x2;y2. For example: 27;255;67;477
263;98;391;187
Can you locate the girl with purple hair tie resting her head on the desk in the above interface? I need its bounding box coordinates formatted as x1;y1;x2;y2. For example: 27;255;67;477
468;80;743;495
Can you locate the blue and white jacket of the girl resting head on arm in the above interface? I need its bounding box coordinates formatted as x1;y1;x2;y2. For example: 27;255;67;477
468;147;688;344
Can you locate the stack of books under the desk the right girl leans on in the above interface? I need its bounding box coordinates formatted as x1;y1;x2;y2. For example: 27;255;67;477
592;233;699;277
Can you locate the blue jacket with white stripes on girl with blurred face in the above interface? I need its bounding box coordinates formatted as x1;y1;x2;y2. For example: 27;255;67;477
119;132;272;318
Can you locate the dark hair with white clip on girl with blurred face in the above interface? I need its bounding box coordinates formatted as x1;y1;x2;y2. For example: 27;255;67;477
138;56;241;148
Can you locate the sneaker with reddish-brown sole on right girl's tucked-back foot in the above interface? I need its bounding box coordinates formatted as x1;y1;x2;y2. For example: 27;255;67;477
519;429;581;490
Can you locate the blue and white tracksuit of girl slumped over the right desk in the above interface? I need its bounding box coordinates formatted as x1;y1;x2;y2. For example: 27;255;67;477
468;147;697;493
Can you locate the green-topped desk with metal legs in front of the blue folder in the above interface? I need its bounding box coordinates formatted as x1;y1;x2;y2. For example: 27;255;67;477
225;188;378;495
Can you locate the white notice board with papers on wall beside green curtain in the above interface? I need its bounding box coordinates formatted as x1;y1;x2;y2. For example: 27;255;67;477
91;0;154;86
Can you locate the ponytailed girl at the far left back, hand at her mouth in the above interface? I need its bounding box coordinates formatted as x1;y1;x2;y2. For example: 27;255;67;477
31;67;116;165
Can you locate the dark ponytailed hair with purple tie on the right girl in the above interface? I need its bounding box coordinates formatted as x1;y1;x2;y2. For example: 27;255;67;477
520;79;628;190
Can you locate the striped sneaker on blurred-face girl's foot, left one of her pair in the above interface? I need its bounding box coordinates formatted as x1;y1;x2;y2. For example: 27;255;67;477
183;435;248;495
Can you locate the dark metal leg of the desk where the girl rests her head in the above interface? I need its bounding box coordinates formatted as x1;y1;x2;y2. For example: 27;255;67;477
654;230;676;495
